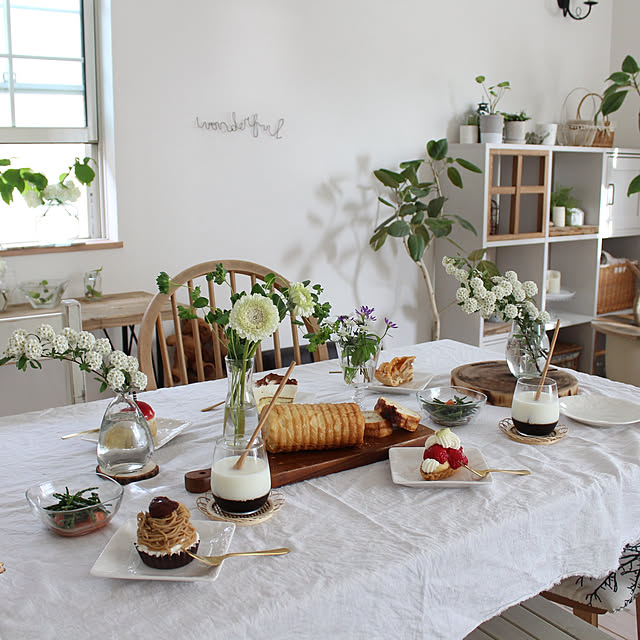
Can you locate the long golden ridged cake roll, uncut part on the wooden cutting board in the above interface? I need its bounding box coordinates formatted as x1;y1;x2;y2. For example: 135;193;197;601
262;402;364;453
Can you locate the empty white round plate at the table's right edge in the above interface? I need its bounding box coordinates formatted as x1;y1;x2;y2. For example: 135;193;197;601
560;395;640;427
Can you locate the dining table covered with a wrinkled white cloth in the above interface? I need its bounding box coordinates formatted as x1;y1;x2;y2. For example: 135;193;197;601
0;340;640;640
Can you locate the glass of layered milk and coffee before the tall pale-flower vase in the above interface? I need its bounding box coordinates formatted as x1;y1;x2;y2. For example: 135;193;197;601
211;434;271;515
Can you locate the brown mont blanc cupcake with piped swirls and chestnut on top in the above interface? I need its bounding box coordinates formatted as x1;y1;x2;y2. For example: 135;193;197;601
136;496;200;569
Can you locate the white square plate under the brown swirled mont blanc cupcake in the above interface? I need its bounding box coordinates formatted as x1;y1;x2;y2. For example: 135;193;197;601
90;519;236;582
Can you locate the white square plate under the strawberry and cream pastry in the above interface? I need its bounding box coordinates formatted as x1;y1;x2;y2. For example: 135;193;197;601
389;447;493;489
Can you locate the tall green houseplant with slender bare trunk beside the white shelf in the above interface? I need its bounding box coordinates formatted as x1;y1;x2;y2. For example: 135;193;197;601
369;138;482;340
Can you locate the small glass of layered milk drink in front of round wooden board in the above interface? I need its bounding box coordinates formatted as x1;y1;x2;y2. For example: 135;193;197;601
511;376;560;436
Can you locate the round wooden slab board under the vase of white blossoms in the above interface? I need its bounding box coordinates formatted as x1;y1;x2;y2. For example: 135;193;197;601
451;360;578;407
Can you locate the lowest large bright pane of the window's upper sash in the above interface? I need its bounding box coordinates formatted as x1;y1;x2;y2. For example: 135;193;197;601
15;91;86;127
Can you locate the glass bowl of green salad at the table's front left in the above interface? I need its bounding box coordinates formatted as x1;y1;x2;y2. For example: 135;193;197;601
25;473;124;537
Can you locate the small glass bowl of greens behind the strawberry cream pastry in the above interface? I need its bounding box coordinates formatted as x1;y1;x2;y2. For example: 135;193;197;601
416;387;487;427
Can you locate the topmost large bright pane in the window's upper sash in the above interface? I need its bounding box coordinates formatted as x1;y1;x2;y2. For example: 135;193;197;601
11;0;82;58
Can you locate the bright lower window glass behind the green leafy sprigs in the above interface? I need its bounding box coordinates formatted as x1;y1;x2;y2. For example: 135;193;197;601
0;144;90;245
